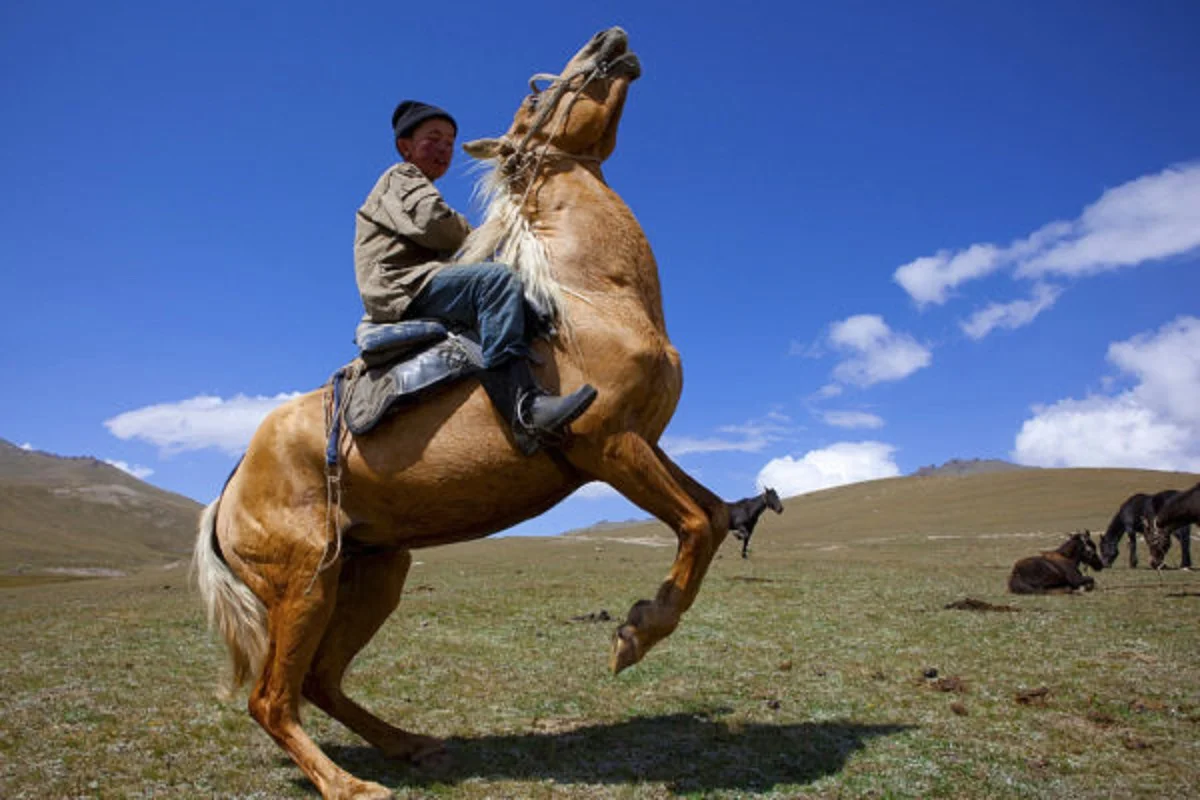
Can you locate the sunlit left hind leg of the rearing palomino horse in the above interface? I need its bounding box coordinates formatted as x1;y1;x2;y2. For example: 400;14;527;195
250;551;392;800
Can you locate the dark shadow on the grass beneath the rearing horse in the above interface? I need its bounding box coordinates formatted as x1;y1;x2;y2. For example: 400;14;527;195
304;709;916;794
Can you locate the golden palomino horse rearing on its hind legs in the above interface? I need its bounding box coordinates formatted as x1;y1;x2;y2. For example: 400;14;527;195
194;28;728;798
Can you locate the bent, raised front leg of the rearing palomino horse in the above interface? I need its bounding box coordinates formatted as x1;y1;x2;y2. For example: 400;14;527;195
570;432;728;673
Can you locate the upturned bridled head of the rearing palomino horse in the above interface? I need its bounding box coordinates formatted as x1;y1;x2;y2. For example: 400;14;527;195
463;28;642;163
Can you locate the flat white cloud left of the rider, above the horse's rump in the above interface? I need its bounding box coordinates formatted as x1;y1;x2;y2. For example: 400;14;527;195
104;392;300;455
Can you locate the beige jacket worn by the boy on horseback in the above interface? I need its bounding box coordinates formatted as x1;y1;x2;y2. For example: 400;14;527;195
354;162;470;323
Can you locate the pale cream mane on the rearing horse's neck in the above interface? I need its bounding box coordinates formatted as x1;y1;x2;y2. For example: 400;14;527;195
455;158;568;325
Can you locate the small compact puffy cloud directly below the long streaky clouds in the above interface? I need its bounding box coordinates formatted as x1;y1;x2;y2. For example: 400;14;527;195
829;314;932;386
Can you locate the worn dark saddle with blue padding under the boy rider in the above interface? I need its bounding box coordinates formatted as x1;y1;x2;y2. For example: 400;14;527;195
334;319;484;435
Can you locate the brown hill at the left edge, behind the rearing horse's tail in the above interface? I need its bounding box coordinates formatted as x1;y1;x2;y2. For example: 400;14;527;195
0;439;202;575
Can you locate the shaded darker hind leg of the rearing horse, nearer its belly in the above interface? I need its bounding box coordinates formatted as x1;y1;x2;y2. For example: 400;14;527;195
304;551;444;762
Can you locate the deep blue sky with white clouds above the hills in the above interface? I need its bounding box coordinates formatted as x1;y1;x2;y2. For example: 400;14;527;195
0;0;1200;534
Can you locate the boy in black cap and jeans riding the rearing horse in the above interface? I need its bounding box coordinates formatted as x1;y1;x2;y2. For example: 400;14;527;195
354;100;596;456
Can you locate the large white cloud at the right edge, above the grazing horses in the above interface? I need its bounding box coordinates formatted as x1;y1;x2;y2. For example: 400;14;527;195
1013;317;1200;471
